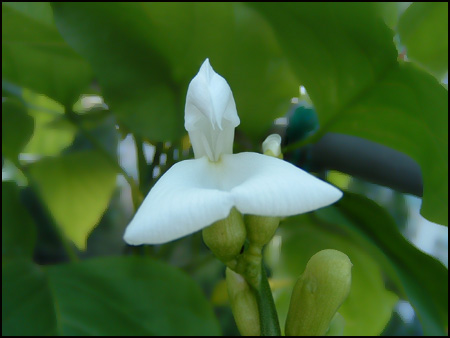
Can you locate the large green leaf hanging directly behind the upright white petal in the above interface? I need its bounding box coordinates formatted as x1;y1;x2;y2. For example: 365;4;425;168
54;3;298;140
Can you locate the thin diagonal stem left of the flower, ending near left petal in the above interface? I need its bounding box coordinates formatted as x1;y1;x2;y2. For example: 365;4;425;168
65;107;143;210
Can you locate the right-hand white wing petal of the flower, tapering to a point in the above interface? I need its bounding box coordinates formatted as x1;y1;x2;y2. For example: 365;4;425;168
221;153;342;216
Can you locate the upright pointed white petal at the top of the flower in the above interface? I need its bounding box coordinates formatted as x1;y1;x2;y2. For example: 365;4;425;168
184;59;240;161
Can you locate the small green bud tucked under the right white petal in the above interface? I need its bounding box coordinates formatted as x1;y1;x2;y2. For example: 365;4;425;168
245;215;280;247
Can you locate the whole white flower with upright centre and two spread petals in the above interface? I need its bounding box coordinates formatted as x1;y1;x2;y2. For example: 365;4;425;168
124;59;342;245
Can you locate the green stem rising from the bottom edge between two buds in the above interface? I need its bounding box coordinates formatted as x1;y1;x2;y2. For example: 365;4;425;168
254;264;281;336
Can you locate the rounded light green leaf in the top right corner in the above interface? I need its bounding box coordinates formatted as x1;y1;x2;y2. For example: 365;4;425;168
398;2;448;78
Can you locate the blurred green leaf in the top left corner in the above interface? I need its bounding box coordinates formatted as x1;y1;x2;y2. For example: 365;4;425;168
2;3;91;105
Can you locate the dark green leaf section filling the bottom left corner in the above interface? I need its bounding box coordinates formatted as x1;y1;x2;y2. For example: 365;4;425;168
2;259;57;336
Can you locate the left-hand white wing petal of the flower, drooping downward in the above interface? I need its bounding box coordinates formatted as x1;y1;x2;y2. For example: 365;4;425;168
124;158;233;245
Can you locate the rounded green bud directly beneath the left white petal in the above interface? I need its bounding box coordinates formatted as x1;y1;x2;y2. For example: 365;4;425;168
202;208;247;264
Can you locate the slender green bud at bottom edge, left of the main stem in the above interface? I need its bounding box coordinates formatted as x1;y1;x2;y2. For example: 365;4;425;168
226;268;260;336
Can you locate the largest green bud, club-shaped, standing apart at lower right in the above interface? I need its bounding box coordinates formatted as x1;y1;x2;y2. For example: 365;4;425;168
285;249;352;336
